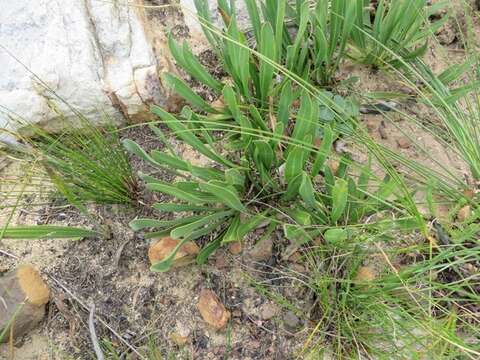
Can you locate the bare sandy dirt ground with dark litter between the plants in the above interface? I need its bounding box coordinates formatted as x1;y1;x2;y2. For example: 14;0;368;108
0;1;480;360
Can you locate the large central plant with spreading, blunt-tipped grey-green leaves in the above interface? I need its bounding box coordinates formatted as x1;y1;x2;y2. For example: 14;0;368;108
124;84;397;271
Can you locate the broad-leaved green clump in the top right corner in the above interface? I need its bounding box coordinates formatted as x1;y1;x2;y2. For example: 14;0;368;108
351;0;447;67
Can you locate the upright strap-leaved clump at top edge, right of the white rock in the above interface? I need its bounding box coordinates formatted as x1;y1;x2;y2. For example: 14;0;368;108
195;0;356;87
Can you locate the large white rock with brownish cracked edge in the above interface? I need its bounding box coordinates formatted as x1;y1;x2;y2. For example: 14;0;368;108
0;0;248;135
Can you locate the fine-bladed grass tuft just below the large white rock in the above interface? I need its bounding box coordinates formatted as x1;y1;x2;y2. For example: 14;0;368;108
4;115;137;210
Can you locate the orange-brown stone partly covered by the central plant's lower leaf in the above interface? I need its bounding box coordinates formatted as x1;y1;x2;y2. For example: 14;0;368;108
148;236;200;267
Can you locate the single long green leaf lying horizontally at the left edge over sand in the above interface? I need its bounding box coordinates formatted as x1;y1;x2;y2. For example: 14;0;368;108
0;225;98;240
